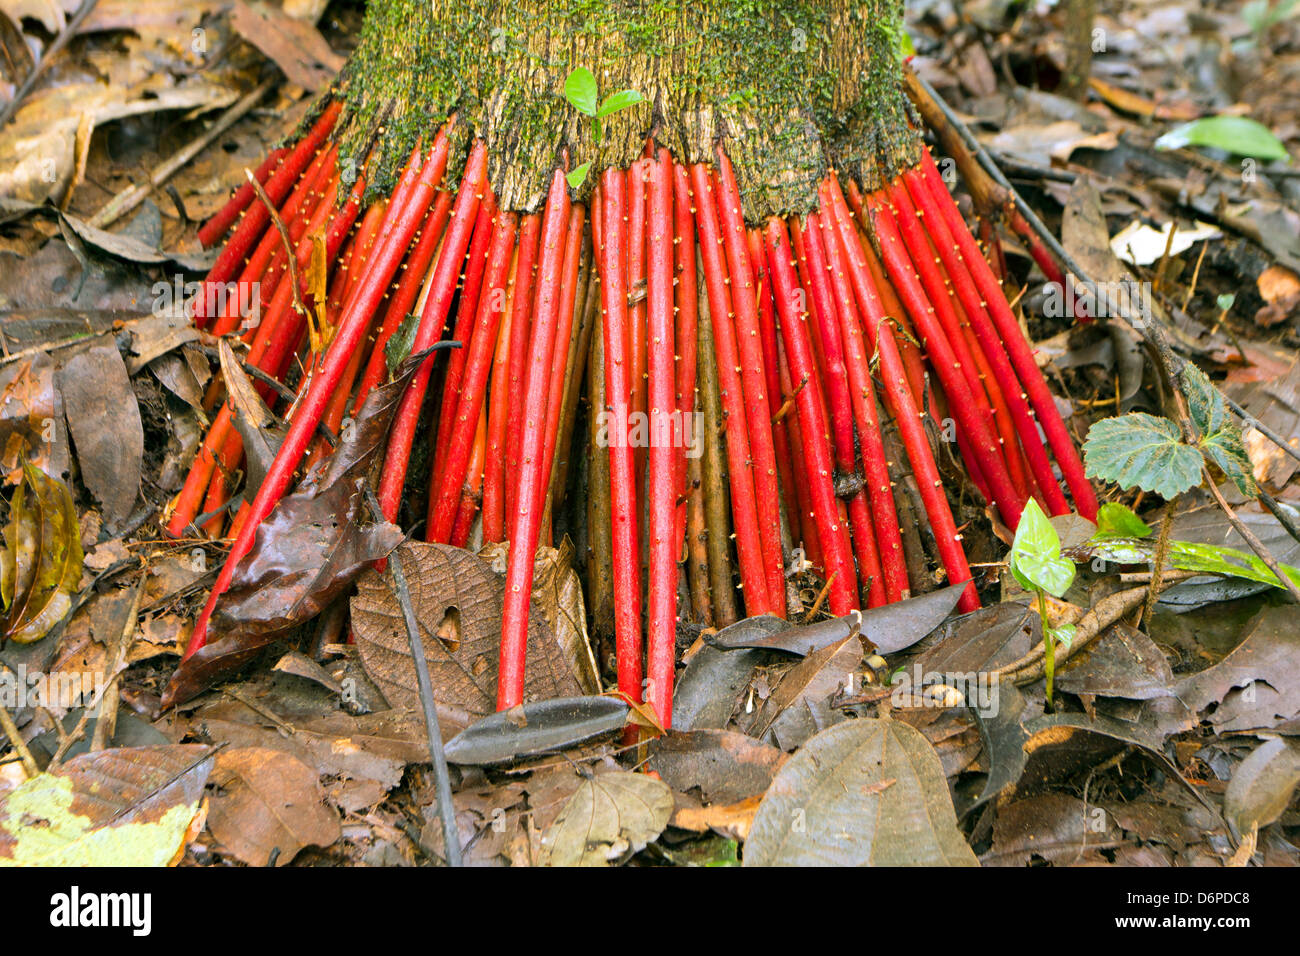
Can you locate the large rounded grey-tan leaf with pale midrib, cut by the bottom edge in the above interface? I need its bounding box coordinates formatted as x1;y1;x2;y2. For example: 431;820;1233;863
745;718;979;866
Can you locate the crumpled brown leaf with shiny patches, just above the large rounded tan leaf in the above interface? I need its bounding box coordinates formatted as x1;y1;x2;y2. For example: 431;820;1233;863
744;637;862;750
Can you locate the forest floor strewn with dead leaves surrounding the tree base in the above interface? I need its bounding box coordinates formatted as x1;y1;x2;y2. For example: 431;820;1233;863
0;0;1300;866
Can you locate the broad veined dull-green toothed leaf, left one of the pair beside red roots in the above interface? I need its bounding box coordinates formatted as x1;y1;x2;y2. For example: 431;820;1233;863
1083;411;1201;501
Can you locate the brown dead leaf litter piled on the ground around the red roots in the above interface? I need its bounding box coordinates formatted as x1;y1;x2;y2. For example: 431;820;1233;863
0;4;1300;865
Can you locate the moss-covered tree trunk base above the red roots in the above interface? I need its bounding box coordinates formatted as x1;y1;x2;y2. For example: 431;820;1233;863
330;0;918;221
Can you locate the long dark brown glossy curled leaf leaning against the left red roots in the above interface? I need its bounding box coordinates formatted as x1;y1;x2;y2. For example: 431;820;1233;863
163;351;429;706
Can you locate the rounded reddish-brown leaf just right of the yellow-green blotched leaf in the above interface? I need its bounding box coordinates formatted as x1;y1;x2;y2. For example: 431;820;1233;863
208;747;342;866
